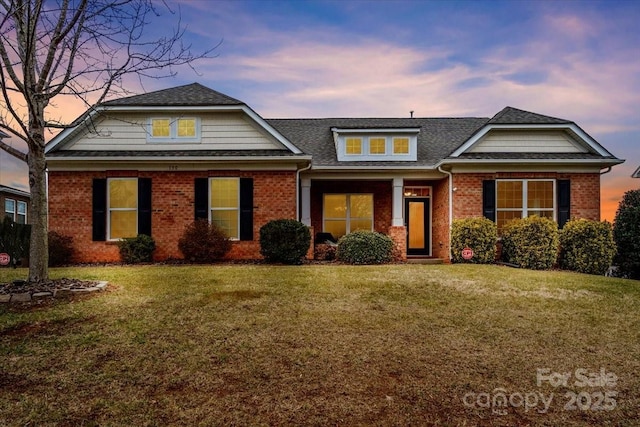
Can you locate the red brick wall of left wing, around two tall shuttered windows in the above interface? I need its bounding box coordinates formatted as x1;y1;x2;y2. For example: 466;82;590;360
49;171;296;262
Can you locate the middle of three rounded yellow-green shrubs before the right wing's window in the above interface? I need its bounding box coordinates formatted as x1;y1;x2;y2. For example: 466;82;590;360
502;215;558;270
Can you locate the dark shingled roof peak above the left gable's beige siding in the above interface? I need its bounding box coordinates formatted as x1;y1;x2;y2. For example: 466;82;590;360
102;83;244;107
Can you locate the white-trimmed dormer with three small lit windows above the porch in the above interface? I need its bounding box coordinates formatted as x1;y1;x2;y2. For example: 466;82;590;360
331;128;420;162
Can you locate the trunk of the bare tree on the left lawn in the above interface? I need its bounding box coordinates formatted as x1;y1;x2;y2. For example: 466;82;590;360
27;125;49;282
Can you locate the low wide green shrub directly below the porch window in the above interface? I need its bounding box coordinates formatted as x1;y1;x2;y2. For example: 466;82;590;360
336;231;394;264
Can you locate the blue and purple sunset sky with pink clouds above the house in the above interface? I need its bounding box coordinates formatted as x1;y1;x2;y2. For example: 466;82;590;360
0;0;640;220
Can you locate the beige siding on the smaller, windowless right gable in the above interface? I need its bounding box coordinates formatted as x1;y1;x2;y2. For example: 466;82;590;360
469;131;587;153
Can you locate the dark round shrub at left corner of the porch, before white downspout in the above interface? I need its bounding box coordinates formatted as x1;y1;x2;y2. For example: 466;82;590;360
260;219;311;264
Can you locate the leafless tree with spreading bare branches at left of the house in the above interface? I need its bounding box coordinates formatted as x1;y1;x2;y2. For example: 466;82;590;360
0;0;216;282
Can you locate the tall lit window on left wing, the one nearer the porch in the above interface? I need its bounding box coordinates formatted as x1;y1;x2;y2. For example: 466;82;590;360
209;178;240;239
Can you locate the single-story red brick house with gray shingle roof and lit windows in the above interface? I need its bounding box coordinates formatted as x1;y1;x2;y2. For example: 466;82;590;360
46;84;623;262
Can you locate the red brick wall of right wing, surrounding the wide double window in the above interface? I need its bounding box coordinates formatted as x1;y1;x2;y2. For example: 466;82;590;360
453;172;600;221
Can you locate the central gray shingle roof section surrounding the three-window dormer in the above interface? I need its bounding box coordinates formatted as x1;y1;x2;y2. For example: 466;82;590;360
266;118;489;167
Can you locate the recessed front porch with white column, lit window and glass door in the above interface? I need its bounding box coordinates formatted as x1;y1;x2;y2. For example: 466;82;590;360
300;175;449;262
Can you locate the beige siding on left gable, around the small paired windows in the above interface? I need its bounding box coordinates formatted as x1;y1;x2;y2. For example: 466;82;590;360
67;113;283;150
